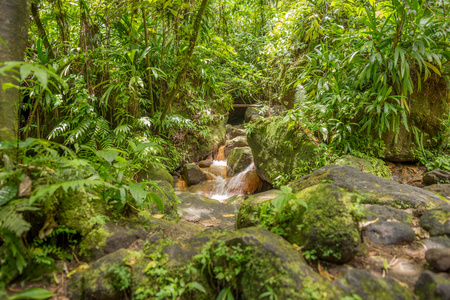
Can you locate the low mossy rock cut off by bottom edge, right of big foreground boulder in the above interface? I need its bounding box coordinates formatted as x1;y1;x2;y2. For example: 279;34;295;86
332;269;414;300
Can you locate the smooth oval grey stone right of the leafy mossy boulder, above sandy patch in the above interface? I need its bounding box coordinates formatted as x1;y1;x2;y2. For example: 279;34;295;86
364;221;416;245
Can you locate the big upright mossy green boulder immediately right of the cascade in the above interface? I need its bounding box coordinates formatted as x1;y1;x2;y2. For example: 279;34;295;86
247;116;318;183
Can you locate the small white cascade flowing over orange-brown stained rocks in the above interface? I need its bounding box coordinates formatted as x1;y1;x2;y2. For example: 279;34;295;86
176;146;263;202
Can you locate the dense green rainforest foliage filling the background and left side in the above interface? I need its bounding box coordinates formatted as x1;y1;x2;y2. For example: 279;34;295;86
0;0;450;292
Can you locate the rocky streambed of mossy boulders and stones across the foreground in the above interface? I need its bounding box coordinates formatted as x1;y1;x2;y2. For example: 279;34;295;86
49;120;450;299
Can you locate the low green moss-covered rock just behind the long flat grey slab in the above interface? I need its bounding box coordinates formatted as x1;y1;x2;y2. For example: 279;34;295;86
335;155;392;179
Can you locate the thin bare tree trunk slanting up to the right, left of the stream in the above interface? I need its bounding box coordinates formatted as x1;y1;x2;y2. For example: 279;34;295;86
159;0;208;129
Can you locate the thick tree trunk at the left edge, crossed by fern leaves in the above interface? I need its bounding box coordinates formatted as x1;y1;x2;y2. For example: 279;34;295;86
0;0;30;140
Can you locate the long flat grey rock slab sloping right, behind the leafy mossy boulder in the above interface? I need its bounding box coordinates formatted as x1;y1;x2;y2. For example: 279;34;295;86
290;164;445;208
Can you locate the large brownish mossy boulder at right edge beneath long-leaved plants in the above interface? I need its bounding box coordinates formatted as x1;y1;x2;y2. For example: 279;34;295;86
382;76;450;161
